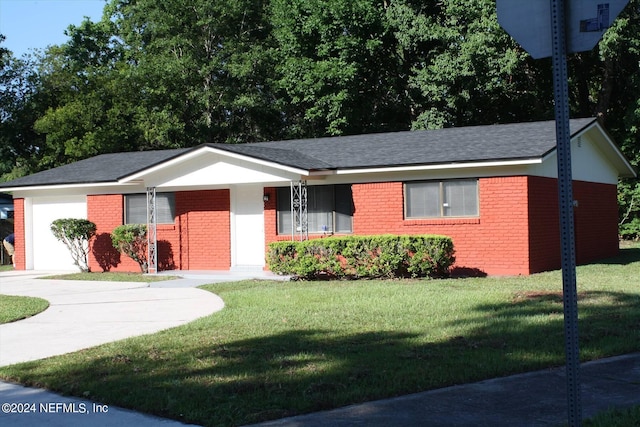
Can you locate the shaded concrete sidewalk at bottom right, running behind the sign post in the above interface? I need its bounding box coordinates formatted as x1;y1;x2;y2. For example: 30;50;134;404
248;353;640;427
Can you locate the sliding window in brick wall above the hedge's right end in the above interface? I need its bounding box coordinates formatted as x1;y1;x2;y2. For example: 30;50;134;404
404;179;479;218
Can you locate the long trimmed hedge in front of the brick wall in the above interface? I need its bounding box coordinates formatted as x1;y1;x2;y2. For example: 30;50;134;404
267;235;455;279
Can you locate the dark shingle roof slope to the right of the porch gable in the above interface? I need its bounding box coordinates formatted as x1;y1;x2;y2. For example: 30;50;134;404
211;118;595;170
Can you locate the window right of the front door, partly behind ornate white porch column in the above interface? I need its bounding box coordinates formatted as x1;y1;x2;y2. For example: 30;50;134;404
276;185;353;234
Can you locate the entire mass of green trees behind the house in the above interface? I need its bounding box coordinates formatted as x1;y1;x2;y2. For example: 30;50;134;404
0;0;640;230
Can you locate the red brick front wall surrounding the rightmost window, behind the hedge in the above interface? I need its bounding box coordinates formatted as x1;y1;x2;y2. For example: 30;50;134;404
352;177;529;274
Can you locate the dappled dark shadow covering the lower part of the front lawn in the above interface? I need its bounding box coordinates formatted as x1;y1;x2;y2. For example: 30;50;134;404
5;291;640;426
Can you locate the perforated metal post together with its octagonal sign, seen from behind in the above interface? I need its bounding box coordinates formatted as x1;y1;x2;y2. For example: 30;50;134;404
496;0;628;427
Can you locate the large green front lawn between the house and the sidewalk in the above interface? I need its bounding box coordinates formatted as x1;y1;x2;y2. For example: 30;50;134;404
0;248;640;426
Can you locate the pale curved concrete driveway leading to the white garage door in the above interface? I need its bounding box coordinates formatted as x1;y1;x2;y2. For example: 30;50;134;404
0;271;224;366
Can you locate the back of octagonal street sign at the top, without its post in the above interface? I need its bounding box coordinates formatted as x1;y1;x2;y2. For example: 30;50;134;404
496;0;629;59
